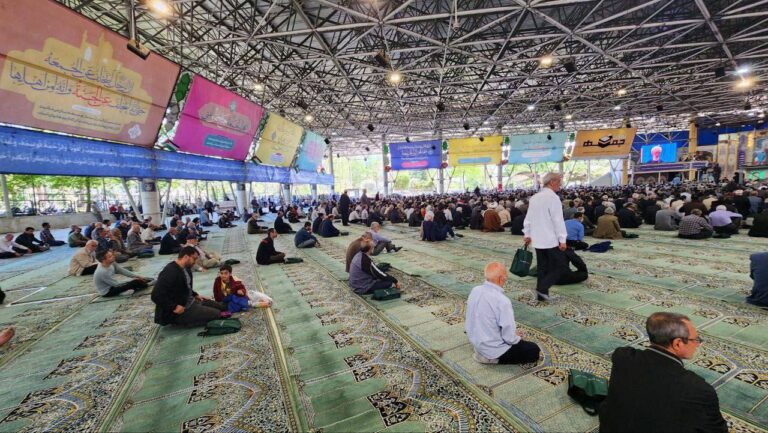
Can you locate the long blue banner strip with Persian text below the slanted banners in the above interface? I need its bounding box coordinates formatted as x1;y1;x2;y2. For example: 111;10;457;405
0;126;333;184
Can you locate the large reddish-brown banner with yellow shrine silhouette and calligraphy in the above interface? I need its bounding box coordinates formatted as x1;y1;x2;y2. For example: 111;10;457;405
0;0;180;146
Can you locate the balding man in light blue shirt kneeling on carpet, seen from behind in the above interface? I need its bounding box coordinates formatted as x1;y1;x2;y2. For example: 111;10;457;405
464;262;541;364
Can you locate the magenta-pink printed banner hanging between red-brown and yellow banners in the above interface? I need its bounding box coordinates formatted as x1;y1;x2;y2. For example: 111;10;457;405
173;75;264;161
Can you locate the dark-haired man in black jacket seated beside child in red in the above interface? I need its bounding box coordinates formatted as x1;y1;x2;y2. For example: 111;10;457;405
152;247;227;326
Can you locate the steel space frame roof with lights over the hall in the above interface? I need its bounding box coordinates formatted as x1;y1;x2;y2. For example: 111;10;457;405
58;0;768;155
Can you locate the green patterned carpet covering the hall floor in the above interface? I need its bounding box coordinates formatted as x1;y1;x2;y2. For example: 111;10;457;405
0;219;768;432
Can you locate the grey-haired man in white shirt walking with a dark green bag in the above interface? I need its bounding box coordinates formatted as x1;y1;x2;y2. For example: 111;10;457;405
523;173;568;301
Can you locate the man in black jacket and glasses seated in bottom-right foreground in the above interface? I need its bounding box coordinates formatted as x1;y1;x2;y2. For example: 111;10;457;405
600;312;728;433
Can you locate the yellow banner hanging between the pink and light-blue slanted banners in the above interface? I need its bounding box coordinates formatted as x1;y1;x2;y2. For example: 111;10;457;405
253;113;304;167
